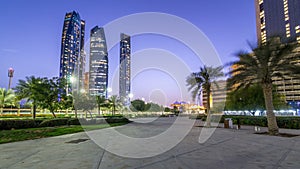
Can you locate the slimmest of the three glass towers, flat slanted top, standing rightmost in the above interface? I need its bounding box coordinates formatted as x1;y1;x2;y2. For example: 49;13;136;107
119;33;131;104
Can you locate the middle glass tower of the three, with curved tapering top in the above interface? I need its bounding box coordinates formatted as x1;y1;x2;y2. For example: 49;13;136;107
89;26;108;98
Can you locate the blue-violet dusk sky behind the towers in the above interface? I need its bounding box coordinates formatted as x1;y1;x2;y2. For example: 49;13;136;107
0;0;257;105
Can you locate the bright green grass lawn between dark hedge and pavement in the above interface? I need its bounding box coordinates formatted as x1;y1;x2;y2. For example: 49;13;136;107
0;123;127;144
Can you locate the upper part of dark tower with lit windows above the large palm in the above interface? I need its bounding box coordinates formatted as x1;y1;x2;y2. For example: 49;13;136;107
255;0;300;43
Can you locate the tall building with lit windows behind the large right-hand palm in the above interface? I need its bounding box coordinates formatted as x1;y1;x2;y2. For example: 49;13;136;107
255;0;300;109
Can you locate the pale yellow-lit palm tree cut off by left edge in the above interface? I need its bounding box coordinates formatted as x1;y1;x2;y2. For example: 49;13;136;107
0;88;15;114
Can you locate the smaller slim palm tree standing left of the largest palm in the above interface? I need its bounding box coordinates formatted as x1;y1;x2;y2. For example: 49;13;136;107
186;66;224;127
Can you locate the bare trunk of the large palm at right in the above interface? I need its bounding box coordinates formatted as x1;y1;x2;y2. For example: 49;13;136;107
263;83;279;135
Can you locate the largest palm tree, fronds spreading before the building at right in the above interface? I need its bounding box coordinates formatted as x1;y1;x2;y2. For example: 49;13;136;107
228;38;300;135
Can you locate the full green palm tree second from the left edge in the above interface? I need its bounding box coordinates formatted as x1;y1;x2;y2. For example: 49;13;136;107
15;76;47;119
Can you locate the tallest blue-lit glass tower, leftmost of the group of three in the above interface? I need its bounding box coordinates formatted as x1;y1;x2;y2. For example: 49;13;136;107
59;11;85;93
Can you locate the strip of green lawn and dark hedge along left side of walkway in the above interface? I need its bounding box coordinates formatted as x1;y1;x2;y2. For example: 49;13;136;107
0;116;130;144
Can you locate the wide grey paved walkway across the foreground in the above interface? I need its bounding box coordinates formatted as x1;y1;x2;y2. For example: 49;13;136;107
0;117;300;169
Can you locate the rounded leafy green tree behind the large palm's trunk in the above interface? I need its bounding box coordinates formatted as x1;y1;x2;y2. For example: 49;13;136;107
226;84;288;115
